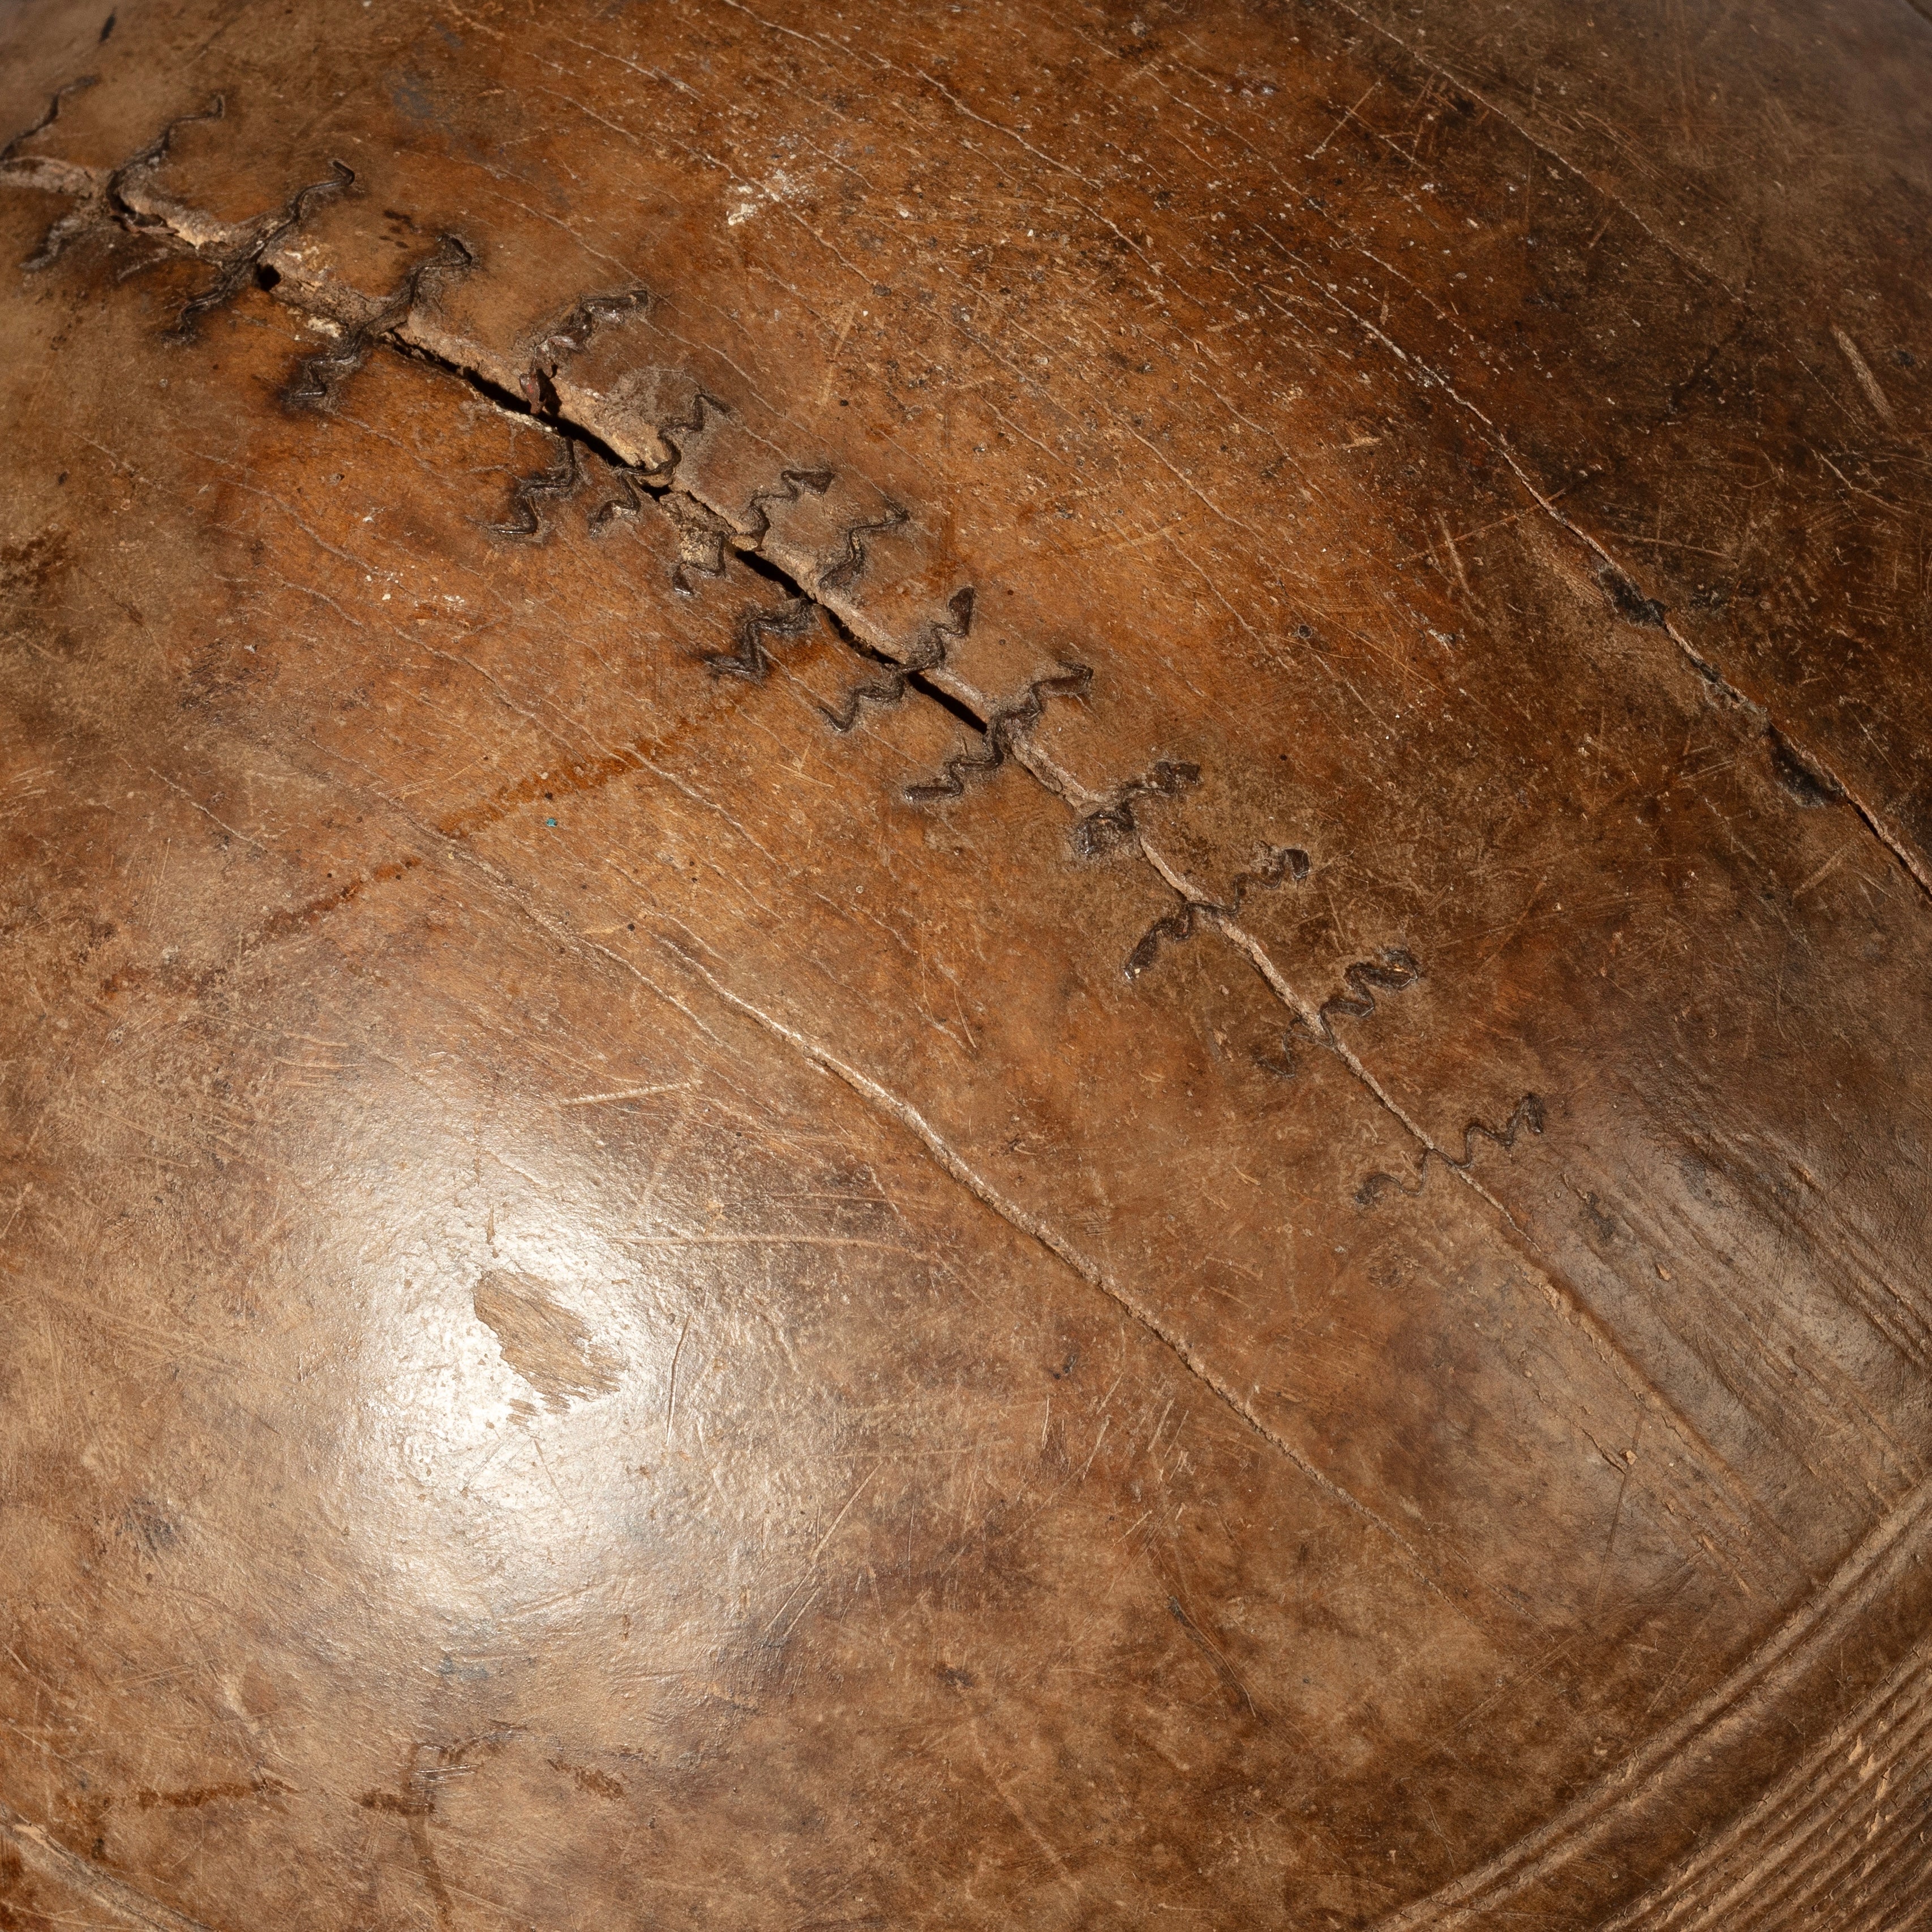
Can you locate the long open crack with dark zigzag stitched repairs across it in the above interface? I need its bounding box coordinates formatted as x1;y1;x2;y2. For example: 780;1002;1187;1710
0;81;1522;1194
